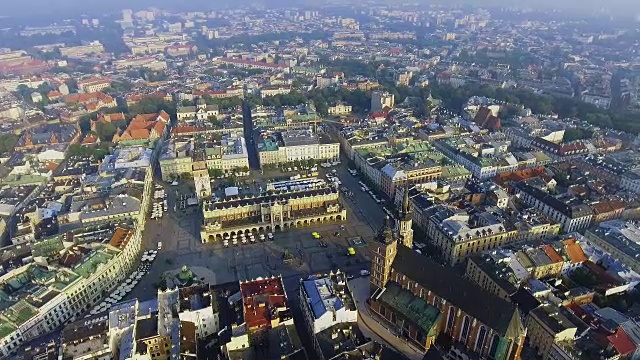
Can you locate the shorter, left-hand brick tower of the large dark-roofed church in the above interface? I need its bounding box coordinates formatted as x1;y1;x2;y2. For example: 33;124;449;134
369;216;398;294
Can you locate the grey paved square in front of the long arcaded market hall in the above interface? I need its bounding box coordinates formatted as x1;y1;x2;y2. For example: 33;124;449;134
128;162;381;299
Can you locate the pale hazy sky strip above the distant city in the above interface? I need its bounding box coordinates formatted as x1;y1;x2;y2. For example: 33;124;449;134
0;0;640;17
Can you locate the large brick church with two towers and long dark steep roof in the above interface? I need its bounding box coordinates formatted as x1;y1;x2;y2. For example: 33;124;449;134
369;188;526;360
